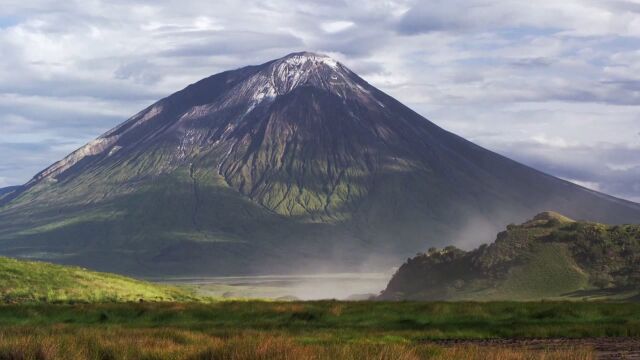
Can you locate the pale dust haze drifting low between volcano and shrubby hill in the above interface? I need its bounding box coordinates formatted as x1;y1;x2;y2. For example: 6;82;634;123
156;210;568;300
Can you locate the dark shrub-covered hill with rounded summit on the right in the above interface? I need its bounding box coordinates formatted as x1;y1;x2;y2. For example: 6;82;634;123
380;212;640;300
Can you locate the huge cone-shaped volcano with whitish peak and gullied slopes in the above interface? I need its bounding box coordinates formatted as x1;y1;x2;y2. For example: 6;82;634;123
0;53;640;274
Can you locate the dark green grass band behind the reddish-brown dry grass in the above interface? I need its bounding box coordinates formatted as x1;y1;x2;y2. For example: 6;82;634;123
0;301;640;343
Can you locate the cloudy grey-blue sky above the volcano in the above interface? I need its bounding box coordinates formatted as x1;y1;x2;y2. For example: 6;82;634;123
0;0;640;202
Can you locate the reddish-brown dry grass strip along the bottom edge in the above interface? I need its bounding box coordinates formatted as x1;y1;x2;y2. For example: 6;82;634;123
0;325;592;360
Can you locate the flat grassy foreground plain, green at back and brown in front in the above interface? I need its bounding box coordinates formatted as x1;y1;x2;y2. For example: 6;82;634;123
0;301;640;360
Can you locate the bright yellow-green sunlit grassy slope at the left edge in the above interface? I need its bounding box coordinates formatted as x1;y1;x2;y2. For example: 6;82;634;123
0;257;196;303
